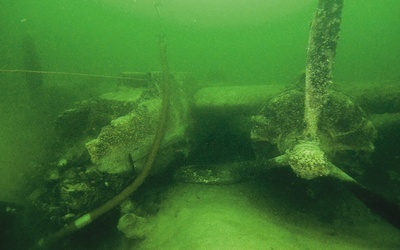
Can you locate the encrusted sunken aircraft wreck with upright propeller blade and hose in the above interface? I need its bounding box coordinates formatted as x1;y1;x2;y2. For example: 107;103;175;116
25;0;400;245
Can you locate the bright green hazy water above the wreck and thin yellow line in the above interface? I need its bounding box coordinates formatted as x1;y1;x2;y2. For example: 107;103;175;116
0;0;400;83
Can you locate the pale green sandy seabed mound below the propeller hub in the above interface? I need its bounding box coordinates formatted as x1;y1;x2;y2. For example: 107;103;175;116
126;183;400;250
